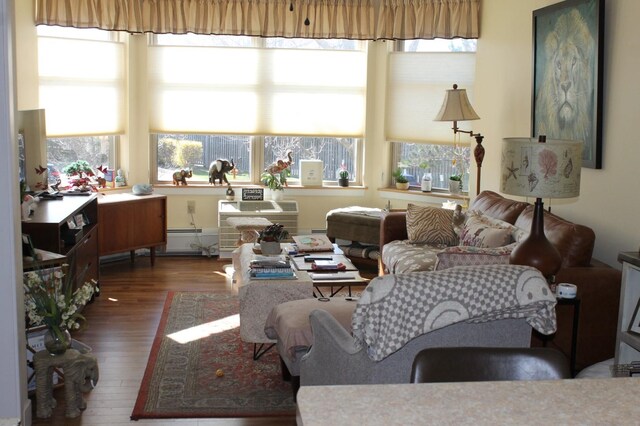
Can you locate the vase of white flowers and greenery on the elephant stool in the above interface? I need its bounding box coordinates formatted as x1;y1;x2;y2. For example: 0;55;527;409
24;264;98;355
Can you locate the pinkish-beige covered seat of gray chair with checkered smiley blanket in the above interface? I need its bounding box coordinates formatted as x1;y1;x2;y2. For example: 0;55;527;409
264;297;357;397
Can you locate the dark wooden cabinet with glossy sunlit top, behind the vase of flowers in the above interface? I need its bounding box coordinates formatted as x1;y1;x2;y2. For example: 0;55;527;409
22;194;100;288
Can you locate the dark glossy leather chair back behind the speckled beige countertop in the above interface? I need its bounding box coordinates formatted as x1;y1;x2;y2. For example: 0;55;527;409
411;347;571;383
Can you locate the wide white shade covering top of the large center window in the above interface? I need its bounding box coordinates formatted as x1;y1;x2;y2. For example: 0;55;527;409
149;46;366;137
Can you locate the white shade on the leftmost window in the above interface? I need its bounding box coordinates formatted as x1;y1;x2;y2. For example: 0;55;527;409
38;37;125;137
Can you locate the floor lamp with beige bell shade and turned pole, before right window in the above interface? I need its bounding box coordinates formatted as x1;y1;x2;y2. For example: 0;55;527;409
434;84;484;194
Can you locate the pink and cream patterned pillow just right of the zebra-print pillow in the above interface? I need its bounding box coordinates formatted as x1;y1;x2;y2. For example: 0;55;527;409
460;211;517;247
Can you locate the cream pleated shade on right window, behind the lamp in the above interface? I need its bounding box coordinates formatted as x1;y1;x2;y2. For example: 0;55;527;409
385;52;476;144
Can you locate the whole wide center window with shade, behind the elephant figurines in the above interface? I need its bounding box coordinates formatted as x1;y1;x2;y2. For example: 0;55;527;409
149;34;367;184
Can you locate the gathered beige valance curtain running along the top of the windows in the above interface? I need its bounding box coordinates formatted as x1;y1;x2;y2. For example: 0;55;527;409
34;0;480;40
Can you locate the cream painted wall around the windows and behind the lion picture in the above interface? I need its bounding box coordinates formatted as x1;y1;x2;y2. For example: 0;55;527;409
16;0;640;267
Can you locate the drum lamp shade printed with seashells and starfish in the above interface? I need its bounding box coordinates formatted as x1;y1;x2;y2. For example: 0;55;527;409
500;138;583;198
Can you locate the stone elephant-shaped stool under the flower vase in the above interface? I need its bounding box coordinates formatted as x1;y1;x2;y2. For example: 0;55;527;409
33;349;98;418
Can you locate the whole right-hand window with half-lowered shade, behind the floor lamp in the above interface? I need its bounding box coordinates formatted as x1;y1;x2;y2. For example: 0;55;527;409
385;39;476;192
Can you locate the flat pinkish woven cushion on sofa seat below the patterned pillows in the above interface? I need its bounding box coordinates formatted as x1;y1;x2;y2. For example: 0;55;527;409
435;243;516;271
